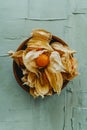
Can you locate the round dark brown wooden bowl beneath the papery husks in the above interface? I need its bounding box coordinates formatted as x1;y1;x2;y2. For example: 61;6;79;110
13;36;69;92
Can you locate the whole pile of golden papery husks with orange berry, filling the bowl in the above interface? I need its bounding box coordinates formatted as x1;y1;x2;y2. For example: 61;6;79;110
9;29;78;97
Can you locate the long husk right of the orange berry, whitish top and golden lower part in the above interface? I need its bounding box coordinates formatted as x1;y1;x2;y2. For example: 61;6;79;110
45;51;65;93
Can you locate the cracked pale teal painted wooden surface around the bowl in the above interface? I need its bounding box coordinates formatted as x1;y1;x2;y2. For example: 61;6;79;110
0;0;87;130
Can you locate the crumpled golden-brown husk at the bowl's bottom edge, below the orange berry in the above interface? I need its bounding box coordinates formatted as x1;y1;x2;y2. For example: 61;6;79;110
22;69;53;98
